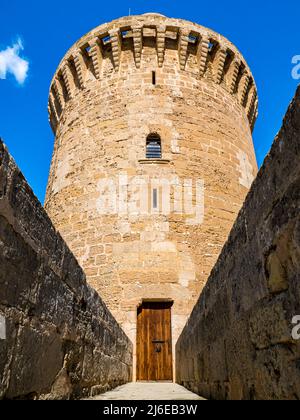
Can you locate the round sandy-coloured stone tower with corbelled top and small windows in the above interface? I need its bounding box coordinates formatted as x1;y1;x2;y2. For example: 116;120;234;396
45;13;258;379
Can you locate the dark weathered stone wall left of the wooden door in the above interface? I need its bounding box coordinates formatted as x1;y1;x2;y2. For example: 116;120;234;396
0;141;132;399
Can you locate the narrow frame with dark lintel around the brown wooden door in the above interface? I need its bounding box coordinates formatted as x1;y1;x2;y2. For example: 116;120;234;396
135;298;174;382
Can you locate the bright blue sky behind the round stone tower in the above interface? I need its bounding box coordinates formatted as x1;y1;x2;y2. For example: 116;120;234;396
0;0;300;202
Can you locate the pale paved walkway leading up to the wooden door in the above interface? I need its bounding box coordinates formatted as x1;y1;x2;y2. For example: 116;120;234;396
92;382;203;401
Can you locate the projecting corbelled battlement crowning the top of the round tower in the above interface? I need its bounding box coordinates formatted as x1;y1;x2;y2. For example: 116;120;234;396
48;13;258;132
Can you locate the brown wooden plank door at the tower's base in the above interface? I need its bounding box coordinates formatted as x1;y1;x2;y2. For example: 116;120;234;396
137;302;173;381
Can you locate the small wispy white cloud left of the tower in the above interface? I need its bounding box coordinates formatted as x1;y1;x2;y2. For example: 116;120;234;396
0;39;29;85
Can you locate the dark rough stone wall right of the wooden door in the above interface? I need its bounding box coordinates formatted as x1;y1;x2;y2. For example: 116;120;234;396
176;88;300;399
